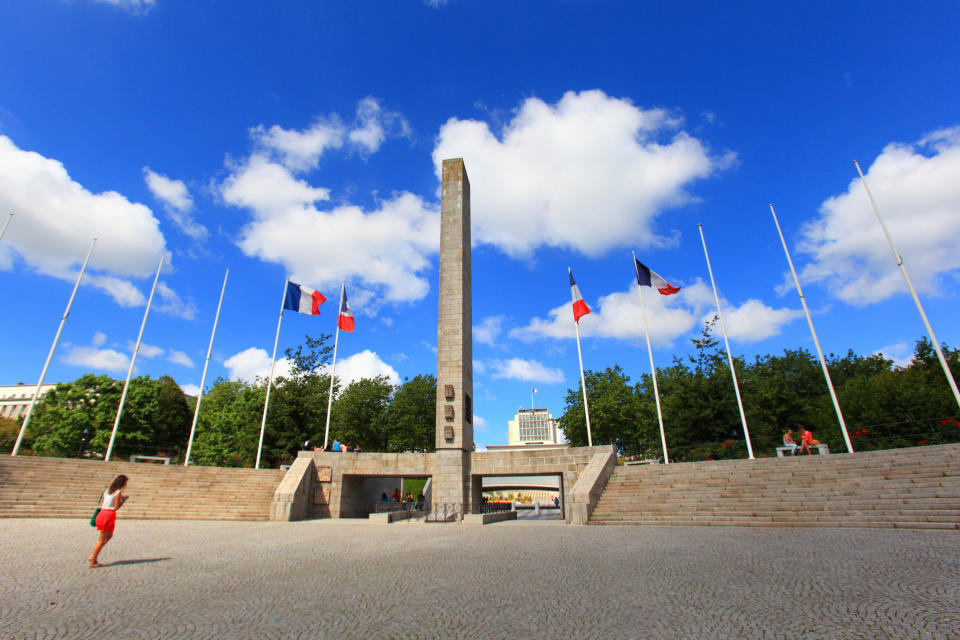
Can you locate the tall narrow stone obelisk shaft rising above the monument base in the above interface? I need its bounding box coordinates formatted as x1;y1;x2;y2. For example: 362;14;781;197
433;158;473;513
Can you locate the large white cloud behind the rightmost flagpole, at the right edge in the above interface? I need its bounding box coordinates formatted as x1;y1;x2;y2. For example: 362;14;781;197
799;126;960;305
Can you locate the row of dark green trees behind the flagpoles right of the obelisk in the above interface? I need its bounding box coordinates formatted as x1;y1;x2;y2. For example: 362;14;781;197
560;322;960;460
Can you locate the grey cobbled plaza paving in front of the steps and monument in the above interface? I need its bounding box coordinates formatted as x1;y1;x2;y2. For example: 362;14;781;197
0;518;960;640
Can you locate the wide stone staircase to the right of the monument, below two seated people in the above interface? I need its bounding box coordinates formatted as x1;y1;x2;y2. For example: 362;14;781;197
590;444;960;529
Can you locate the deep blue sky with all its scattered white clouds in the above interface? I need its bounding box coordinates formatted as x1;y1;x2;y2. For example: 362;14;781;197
0;0;960;445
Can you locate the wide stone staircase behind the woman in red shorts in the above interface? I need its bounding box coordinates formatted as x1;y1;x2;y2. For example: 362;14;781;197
0;456;286;520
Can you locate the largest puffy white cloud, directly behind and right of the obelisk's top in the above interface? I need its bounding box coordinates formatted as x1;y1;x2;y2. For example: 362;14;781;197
433;90;733;256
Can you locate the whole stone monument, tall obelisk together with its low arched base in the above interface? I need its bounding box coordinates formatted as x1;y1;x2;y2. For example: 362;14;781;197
270;158;616;524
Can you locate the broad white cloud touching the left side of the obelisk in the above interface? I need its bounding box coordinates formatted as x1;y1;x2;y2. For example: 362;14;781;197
221;156;440;304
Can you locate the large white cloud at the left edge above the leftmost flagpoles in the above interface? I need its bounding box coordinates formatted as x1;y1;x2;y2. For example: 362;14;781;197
0;135;195;314
